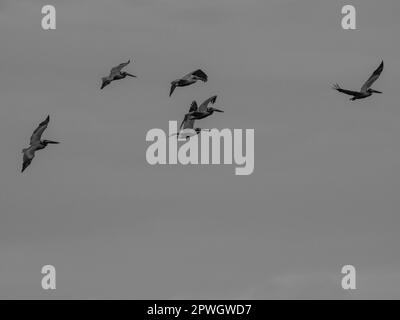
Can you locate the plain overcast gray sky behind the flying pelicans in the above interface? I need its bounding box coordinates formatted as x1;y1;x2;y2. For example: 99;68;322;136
0;0;400;299
